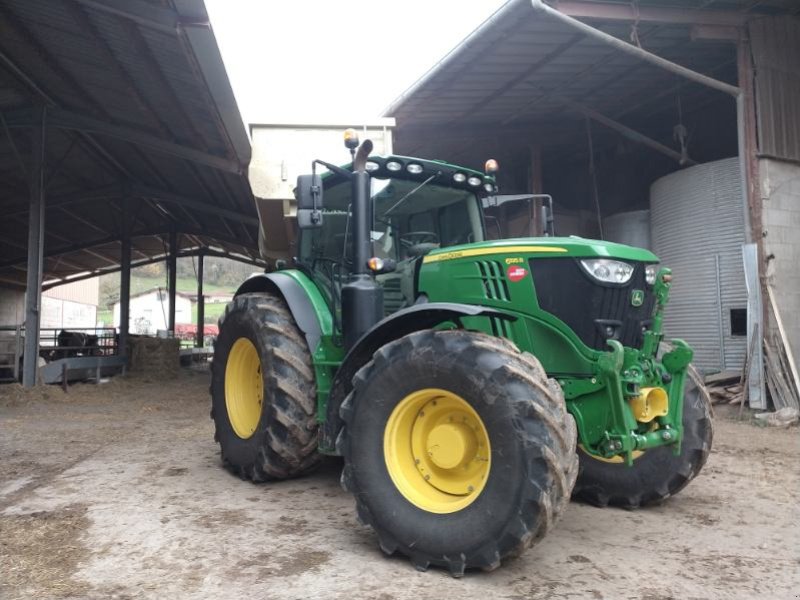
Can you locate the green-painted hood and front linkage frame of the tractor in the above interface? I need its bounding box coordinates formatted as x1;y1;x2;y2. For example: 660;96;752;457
419;248;691;464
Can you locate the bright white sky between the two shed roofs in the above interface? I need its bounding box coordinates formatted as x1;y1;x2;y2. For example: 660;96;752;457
206;0;504;123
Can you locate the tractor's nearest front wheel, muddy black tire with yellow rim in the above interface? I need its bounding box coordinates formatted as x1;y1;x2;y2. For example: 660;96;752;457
337;330;578;577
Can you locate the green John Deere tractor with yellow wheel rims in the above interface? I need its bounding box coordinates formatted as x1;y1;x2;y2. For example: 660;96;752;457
211;134;712;576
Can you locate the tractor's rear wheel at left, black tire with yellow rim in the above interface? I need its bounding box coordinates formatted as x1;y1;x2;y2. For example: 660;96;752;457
211;293;321;482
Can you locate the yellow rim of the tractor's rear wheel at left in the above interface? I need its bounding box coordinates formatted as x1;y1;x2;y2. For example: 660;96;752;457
225;337;264;440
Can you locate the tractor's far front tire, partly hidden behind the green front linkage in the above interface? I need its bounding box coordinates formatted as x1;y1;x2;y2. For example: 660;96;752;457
573;358;714;509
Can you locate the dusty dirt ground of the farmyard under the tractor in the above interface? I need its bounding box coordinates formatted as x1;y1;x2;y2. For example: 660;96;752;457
0;372;800;600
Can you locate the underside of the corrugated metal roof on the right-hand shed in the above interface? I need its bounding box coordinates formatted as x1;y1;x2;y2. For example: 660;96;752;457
385;0;800;171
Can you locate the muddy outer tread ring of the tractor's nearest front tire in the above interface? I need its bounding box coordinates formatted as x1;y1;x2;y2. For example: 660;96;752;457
337;330;578;577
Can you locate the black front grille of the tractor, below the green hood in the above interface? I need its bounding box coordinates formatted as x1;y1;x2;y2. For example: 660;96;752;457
530;258;655;350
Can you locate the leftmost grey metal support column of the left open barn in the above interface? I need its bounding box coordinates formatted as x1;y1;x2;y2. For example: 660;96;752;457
22;106;47;387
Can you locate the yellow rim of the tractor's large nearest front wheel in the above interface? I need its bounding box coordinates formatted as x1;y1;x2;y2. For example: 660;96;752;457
383;388;492;514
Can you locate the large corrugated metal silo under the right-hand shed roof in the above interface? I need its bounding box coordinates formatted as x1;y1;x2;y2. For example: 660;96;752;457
650;158;747;370
